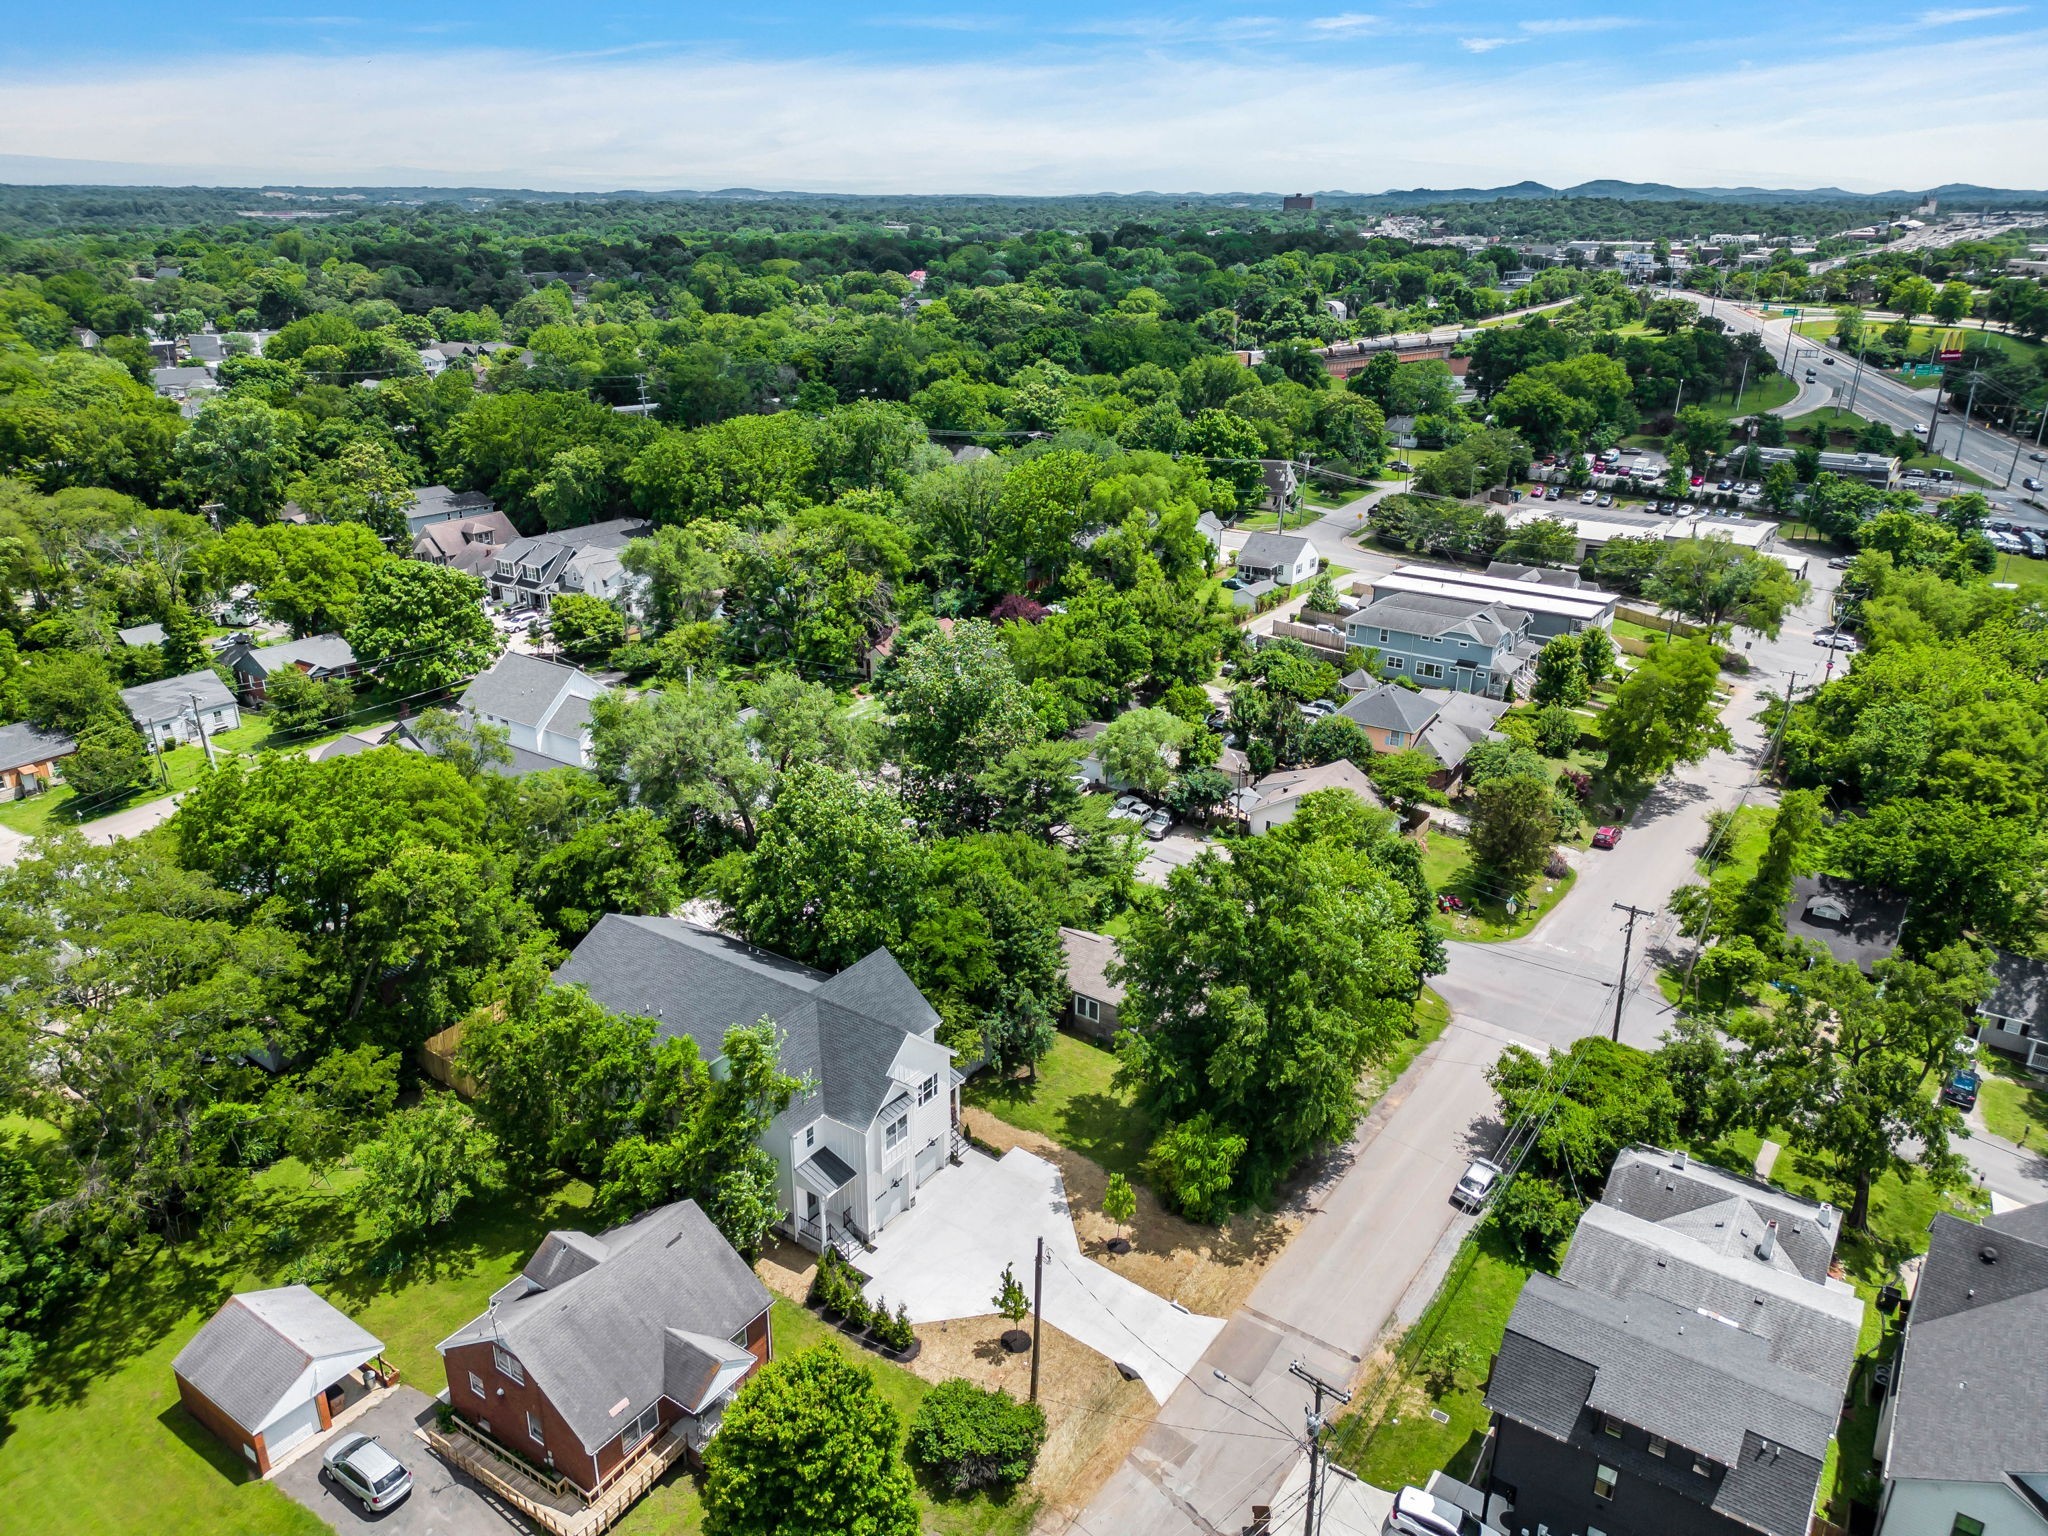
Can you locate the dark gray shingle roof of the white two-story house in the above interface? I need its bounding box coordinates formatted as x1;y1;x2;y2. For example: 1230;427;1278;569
555;913;938;1126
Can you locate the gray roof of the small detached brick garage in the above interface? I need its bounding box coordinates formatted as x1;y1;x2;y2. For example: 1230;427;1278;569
170;1286;383;1434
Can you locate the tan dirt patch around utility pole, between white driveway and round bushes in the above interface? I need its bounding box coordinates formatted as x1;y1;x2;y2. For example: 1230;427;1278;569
909;1315;1159;1528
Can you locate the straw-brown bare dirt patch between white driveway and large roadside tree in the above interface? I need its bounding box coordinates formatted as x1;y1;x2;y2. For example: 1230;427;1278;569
961;1106;1300;1317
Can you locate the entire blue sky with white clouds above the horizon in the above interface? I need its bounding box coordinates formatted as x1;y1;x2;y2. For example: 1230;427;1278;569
0;0;2048;193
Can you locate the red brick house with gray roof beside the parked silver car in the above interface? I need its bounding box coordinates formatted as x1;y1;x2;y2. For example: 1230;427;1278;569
438;1200;774;1495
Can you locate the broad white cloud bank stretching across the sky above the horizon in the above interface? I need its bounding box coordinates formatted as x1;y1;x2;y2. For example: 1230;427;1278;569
0;23;2048;193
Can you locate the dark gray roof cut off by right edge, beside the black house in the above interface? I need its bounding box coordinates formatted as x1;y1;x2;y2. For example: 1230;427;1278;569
1878;1204;2048;1483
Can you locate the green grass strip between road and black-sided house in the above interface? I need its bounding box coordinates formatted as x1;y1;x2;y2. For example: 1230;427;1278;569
1331;1223;1530;1489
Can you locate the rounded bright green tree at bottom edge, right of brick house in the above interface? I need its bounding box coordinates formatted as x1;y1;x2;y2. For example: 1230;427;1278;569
705;1343;920;1536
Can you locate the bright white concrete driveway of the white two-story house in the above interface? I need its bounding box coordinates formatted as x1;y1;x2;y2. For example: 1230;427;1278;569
860;1147;1223;1403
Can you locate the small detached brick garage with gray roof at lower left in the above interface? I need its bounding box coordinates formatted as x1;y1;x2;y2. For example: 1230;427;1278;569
170;1286;395;1477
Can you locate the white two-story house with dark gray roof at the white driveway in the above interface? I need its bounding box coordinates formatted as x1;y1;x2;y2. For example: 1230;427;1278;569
555;913;965;1251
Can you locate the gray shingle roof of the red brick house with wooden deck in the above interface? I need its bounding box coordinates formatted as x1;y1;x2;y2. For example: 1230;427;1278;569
440;1200;768;1450
